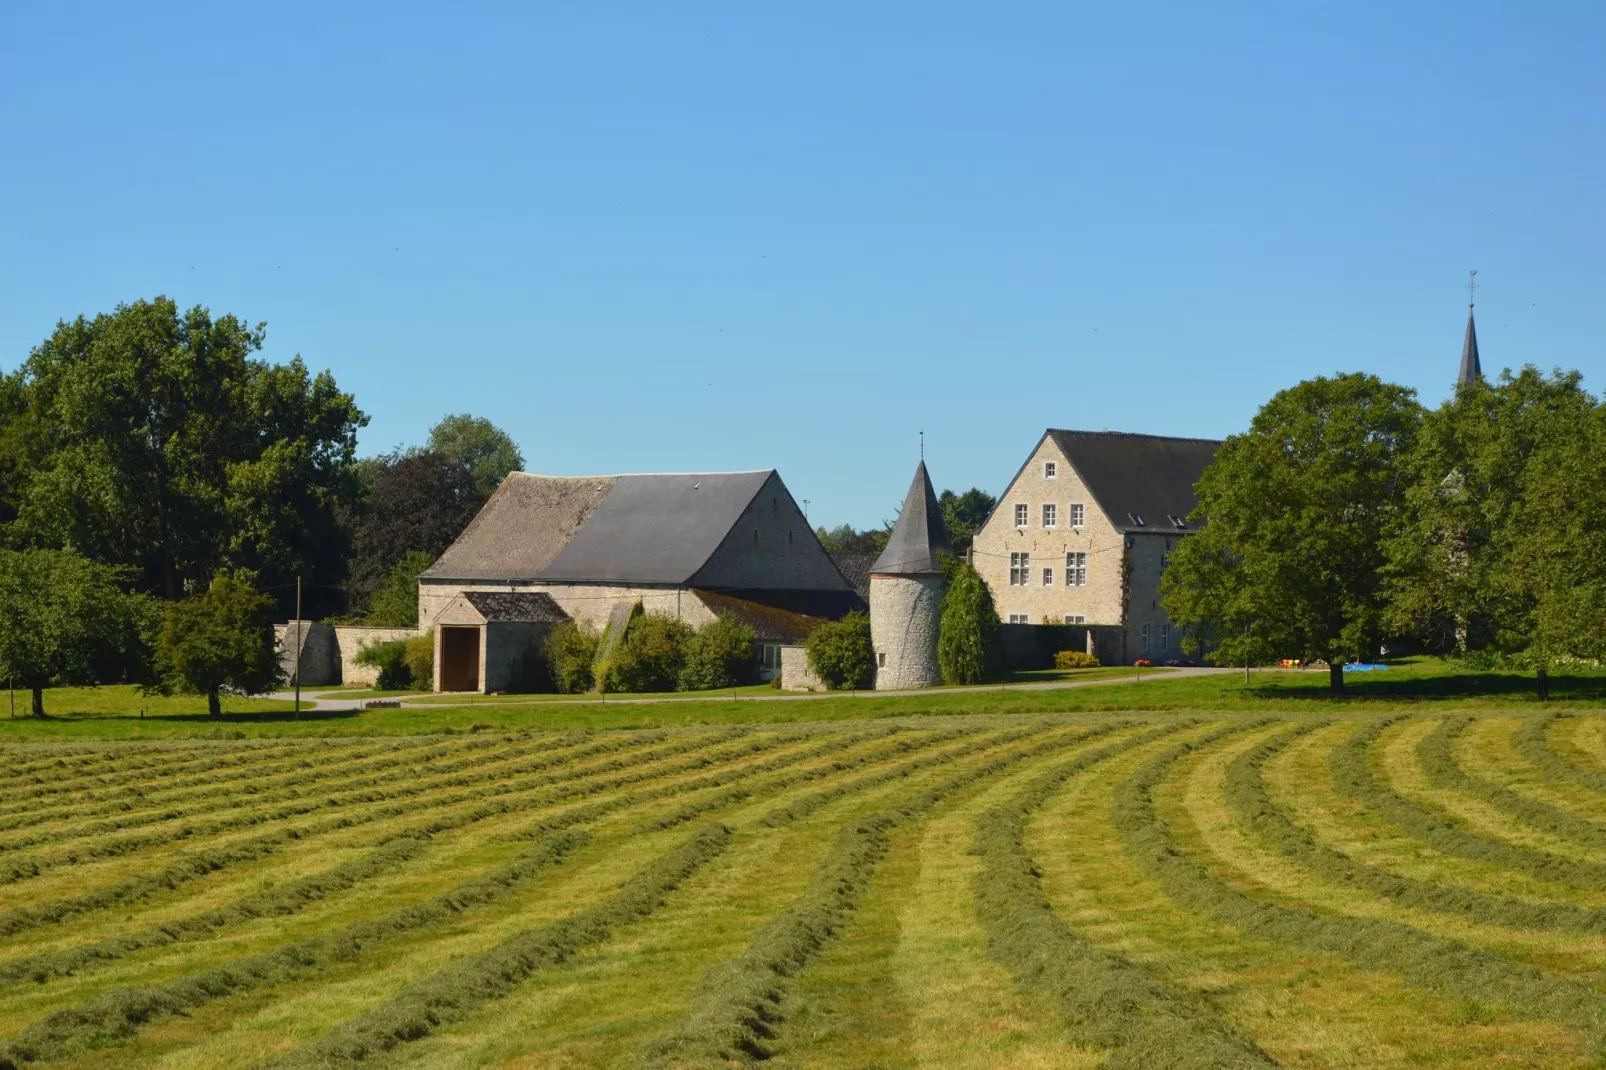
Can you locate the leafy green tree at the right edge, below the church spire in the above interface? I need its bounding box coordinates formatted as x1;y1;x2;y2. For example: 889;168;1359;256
1386;366;1606;697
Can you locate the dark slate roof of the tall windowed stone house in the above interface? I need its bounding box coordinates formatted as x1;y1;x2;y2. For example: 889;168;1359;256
1047;429;1221;532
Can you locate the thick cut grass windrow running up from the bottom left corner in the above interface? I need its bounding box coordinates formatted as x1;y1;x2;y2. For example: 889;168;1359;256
0;831;588;1070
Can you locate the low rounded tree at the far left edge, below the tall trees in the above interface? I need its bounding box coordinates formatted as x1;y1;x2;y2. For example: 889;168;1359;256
0;549;148;717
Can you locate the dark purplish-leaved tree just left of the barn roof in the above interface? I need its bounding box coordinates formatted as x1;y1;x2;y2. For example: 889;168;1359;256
350;450;485;607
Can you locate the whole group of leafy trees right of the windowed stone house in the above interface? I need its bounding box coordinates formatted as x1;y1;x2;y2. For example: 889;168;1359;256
1161;366;1606;699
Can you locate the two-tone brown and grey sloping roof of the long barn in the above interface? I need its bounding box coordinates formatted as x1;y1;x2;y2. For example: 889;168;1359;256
422;469;774;583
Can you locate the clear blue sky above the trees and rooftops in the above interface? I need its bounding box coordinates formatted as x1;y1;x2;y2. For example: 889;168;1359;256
0;2;1606;525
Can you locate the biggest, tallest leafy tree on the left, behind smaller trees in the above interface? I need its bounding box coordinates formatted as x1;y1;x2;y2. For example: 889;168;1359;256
0;297;366;616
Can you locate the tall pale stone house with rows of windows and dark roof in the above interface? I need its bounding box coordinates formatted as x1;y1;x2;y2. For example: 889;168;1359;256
973;429;1221;664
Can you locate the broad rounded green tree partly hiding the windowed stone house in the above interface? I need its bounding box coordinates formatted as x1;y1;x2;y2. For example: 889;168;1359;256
1160;373;1421;694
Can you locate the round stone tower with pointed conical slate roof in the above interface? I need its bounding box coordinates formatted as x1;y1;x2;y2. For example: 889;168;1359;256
870;461;948;691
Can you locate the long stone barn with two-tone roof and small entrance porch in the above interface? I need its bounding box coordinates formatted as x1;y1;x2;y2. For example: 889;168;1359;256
418;469;864;691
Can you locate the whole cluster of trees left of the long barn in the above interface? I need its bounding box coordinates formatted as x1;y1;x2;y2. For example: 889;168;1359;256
0;297;524;713
